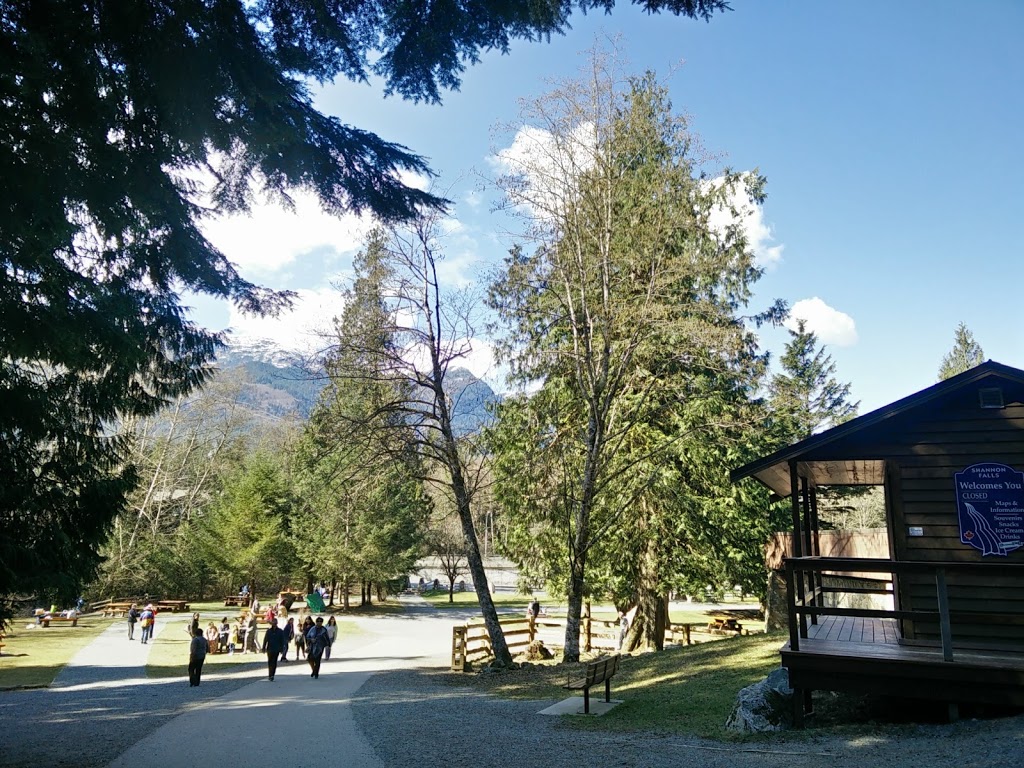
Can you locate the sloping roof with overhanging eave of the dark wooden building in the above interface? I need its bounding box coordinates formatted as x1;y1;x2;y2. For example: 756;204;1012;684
730;360;1024;499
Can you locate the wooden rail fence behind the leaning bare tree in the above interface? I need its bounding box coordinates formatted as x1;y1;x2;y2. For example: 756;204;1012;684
452;615;750;672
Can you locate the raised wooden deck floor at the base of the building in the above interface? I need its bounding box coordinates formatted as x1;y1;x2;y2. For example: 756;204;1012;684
781;616;1024;706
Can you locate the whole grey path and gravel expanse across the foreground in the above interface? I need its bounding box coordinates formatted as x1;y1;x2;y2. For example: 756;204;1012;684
0;601;1024;768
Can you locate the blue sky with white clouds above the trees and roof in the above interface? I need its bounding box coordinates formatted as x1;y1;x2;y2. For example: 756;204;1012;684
194;0;1024;413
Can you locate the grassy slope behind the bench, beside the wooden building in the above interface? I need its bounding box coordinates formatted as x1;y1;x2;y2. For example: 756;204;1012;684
440;633;785;740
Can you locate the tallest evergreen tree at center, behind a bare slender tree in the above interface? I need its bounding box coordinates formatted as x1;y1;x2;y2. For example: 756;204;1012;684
490;54;781;660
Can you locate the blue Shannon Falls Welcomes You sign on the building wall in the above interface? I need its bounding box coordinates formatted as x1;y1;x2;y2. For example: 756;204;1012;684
953;462;1024;557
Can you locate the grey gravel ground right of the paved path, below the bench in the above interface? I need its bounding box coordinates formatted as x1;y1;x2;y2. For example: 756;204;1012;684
352;671;1024;768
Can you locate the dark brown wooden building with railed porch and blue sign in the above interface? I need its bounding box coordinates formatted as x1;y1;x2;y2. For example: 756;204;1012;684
732;361;1024;725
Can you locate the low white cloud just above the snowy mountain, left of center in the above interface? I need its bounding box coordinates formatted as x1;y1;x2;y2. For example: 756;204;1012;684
228;288;343;353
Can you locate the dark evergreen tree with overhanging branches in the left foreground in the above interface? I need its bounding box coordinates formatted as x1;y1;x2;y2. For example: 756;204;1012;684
0;0;728;618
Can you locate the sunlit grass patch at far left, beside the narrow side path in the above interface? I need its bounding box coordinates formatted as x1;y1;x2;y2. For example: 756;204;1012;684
0;615;124;688
